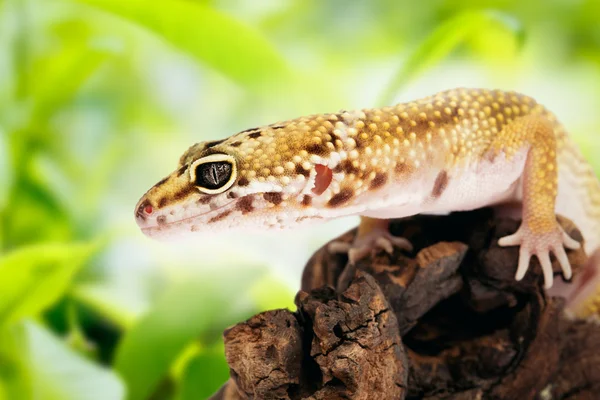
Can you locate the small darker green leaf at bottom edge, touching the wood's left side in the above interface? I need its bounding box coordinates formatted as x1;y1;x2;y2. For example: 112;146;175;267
177;346;229;400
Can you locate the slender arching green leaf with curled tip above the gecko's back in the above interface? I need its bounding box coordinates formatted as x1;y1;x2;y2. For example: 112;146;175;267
378;10;523;106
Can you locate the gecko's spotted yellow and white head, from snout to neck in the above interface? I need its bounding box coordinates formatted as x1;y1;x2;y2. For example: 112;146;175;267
135;125;360;238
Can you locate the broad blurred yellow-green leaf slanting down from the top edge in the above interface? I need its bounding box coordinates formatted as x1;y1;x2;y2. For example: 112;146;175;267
78;0;289;88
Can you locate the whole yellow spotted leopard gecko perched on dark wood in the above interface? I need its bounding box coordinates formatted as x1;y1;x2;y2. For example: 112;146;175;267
135;88;600;315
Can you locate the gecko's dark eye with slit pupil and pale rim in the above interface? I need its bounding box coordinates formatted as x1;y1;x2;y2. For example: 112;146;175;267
190;154;236;194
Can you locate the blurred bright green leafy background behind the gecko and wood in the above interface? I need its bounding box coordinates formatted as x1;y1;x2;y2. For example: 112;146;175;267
0;0;600;400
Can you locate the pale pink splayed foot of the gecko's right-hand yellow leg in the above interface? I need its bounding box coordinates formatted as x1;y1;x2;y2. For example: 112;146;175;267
498;223;581;289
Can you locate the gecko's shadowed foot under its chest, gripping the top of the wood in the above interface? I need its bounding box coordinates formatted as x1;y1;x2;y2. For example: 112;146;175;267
329;229;413;264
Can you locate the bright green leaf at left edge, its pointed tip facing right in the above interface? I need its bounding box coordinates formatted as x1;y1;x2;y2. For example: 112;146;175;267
0;243;99;326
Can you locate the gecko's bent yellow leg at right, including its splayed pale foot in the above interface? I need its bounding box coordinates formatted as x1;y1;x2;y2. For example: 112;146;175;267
491;115;580;288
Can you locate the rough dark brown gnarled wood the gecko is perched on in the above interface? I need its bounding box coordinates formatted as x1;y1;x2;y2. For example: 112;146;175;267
213;210;600;400
